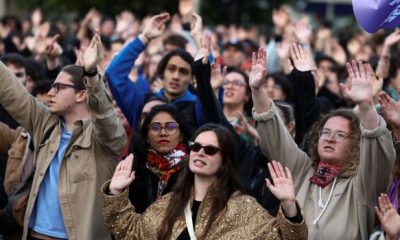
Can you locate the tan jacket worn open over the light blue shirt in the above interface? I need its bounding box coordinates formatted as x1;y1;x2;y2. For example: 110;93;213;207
0;63;126;240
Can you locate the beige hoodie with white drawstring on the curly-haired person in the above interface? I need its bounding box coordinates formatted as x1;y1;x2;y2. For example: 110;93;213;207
253;103;395;239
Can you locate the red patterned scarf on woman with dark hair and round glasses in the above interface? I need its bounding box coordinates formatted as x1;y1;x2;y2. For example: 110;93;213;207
146;143;189;198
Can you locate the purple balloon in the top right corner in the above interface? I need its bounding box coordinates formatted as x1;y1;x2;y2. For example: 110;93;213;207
352;0;400;33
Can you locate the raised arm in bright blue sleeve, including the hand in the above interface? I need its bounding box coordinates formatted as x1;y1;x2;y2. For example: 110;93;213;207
105;13;170;127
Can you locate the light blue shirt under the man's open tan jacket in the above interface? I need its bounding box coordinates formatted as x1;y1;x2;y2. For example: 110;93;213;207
29;123;71;239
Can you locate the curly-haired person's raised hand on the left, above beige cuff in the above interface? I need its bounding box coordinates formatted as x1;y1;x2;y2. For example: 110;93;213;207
249;48;267;90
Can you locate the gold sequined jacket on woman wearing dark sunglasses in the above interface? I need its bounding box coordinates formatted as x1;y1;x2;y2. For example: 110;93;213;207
101;181;307;240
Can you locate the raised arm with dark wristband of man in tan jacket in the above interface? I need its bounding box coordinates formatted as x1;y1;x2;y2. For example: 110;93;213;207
83;30;126;158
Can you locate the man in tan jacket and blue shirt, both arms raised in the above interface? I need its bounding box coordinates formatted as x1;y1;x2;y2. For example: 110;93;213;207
0;32;126;239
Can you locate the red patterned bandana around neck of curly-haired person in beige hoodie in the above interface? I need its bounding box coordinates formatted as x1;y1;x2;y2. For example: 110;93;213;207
310;161;344;188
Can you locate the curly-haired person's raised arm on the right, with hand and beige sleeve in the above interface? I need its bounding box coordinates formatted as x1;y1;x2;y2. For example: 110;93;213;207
341;61;395;202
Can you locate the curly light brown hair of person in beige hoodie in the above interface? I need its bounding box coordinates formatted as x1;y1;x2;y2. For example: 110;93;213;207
304;109;361;177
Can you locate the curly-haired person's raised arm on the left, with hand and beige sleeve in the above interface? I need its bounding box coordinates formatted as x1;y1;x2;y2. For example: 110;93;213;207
250;48;312;188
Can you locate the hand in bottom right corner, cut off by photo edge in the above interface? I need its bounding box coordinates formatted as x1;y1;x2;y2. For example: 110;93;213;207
375;193;400;239
